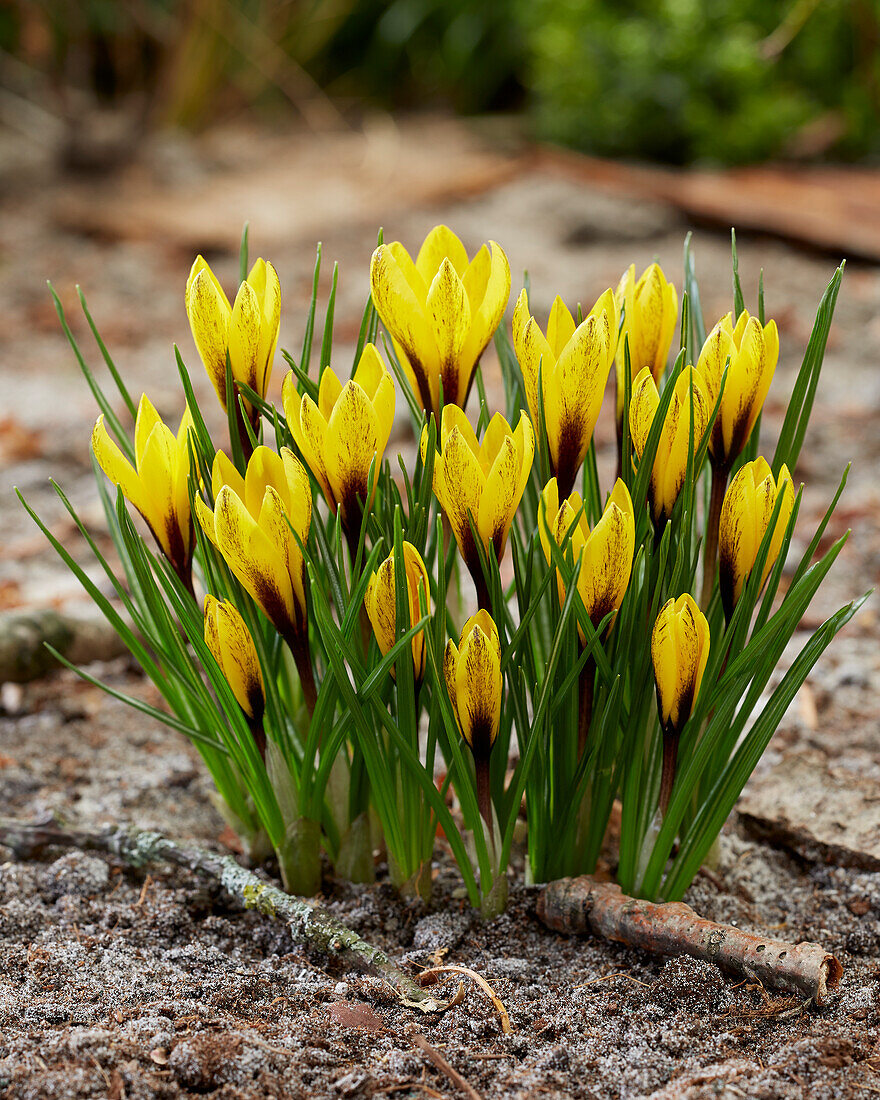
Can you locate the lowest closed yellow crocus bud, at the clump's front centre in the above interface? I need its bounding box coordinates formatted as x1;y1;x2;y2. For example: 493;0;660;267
443;611;502;760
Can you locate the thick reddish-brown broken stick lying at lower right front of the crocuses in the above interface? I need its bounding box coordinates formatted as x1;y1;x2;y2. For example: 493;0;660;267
538;875;844;1004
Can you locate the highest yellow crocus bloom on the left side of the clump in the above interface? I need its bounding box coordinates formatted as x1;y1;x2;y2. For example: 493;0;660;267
186;256;282;409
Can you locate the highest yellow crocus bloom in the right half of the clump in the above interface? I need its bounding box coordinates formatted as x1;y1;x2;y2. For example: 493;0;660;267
617;264;679;422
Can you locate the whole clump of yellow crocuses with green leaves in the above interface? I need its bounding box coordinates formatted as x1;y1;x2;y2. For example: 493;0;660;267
36;226;855;915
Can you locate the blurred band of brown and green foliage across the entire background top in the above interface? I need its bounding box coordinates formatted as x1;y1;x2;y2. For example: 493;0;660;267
6;0;880;164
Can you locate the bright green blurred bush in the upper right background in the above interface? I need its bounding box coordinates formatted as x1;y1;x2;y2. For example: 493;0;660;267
516;0;880;164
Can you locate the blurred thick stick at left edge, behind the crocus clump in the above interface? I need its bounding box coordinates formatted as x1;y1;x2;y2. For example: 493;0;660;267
0;608;128;683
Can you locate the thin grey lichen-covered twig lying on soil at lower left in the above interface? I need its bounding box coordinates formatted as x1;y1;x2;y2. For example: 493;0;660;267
0;817;449;1013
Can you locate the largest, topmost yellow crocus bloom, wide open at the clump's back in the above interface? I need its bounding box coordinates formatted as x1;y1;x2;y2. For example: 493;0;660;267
370;226;510;420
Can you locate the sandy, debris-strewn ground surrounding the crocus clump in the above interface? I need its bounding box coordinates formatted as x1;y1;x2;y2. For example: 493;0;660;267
0;116;880;1100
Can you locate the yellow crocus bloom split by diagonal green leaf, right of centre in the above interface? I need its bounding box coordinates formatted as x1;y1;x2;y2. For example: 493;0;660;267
629;366;710;527
